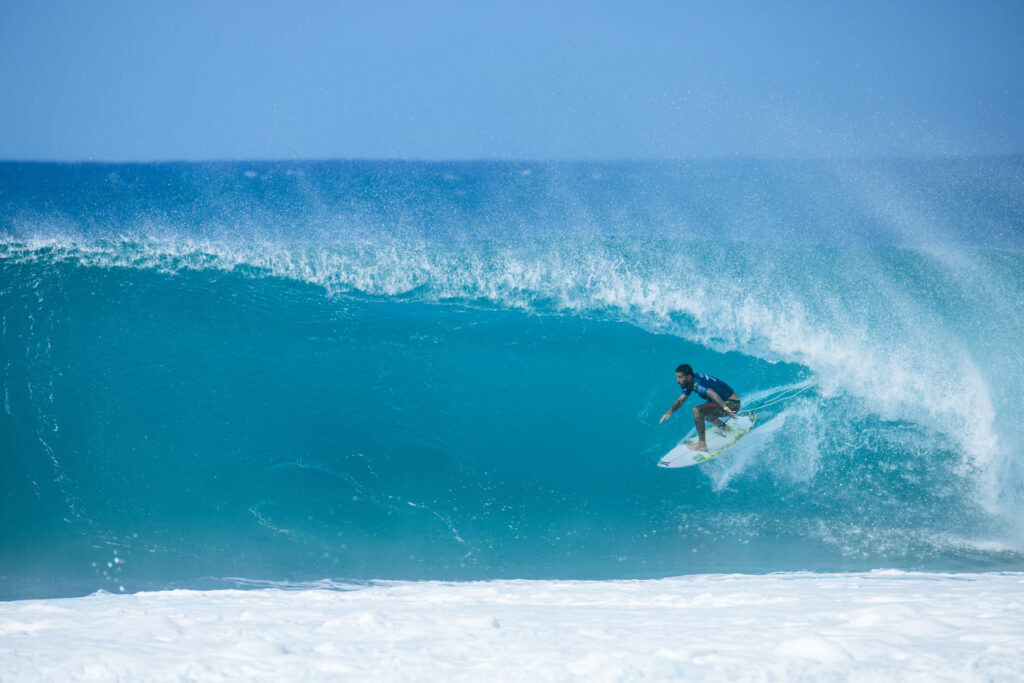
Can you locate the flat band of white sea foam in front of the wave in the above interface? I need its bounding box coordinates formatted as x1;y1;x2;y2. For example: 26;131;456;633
0;571;1024;681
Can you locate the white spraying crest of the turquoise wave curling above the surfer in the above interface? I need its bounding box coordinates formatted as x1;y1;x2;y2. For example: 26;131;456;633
2;238;1024;466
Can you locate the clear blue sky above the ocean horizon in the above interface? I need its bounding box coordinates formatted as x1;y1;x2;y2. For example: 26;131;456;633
0;0;1024;161
